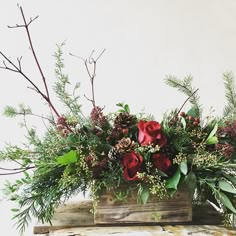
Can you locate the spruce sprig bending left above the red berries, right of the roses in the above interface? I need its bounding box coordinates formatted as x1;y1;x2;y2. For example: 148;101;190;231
165;75;202;116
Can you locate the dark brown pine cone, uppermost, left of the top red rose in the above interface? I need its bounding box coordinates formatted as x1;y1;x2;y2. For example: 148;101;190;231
114;112;136;129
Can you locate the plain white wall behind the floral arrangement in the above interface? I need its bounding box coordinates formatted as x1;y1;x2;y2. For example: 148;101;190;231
0;0;236;236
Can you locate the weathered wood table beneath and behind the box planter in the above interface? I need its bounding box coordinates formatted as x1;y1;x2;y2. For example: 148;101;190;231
34;200;236;236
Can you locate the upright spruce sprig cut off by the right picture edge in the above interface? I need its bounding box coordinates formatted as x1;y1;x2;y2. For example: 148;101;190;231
223;72;236;116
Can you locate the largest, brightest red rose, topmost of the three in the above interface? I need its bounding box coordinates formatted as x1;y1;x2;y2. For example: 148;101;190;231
138;120;167;147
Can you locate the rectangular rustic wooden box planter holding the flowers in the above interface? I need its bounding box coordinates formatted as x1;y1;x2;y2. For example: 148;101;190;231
94;188;192;224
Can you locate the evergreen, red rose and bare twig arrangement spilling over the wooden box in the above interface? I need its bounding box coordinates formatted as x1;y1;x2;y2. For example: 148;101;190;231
0;8;236;234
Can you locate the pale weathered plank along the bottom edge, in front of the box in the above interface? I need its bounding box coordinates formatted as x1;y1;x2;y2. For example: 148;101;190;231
43;225;236;236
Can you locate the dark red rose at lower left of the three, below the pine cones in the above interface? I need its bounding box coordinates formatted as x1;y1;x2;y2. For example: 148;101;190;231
122;152;143;180
